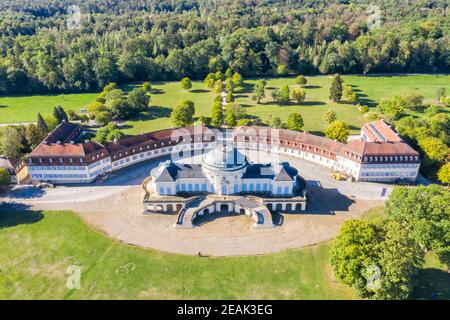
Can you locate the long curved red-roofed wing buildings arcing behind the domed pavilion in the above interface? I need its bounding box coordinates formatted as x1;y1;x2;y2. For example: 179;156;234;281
25;120;420;186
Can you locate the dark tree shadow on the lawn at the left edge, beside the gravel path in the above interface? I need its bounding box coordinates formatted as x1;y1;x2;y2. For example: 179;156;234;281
0;203;44;230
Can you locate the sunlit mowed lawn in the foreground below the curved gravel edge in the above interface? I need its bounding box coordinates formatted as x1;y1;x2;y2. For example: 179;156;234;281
0;211;450;299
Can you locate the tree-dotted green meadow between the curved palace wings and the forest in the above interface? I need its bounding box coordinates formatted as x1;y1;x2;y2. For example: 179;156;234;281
0;75;450;134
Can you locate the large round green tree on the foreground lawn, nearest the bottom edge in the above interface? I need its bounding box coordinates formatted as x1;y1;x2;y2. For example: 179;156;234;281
331;220;423;299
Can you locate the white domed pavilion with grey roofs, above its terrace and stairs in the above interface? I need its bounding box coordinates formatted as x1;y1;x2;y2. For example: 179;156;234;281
151;134;298;196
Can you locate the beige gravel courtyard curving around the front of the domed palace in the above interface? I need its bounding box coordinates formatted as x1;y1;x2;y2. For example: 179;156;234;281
0;157;392;256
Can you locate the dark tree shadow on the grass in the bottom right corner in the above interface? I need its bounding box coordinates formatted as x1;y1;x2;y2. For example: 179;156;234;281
411;268;450;300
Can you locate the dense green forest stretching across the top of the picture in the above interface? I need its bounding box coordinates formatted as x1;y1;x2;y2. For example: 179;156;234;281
0;0;450;95
